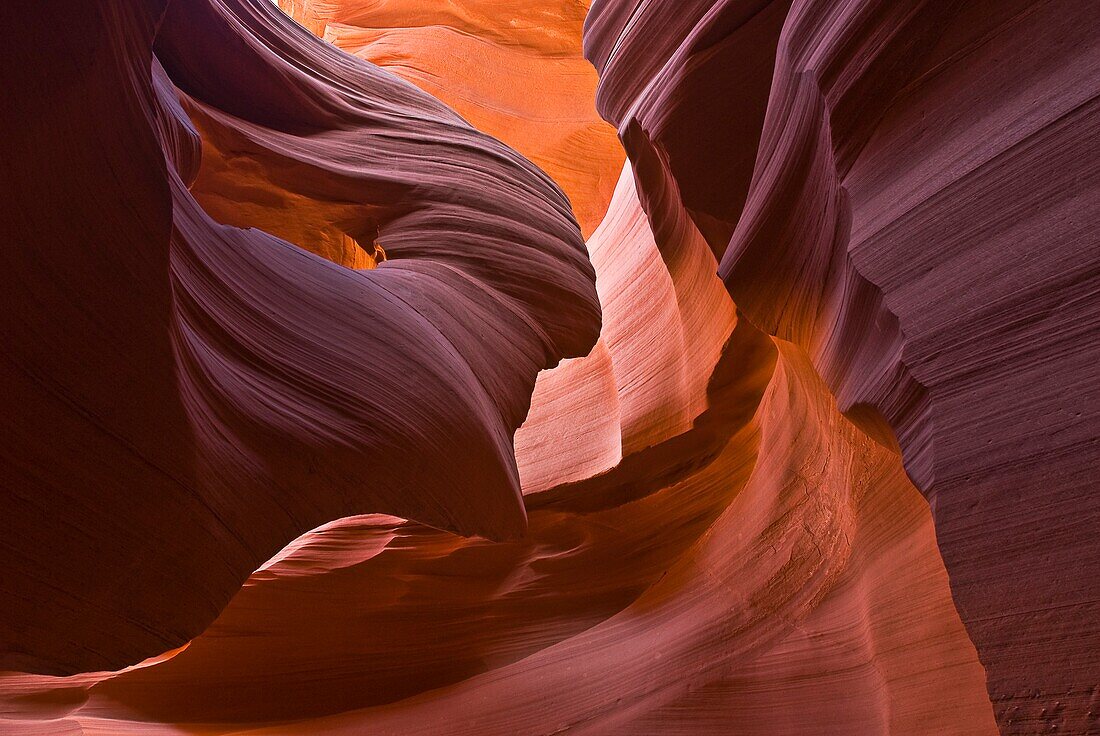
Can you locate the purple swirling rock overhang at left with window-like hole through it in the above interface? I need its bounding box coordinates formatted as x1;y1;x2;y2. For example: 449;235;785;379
0;0;600;674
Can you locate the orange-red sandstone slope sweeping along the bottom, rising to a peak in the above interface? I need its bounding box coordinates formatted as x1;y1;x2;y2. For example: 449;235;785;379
0;325;993;734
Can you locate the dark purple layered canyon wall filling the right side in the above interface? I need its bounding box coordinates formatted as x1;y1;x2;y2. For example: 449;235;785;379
586;0;1100;734
